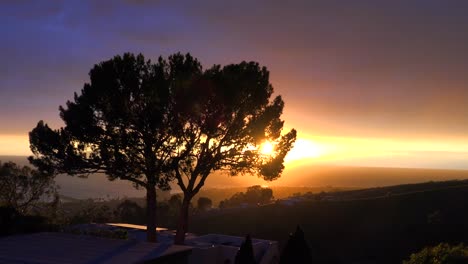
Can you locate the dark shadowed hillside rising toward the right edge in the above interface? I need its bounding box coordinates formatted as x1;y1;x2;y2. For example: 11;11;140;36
189;181;468;264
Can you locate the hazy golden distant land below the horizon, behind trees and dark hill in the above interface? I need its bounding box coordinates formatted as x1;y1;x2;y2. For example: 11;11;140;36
0;156;468;199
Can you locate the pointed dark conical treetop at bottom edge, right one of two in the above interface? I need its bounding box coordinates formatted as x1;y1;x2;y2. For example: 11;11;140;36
280;226;312;264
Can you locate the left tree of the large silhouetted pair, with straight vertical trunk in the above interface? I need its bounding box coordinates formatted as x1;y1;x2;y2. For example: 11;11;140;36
29;53;192;242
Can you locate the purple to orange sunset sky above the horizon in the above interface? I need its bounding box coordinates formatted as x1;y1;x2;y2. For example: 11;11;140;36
0;0;468;169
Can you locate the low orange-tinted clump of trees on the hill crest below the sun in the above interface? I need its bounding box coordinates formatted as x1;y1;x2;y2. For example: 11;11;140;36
219;185;273;208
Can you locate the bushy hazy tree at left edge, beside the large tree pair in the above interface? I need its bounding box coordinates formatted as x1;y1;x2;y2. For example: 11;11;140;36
0;162;58;213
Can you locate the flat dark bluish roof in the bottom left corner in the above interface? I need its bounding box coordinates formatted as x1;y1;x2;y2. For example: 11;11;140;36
0;232;192;264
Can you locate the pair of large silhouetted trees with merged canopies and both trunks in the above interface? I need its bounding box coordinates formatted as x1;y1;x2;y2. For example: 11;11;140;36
30;53;296;243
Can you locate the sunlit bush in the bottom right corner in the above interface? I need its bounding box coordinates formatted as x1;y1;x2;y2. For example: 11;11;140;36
403;243;468;264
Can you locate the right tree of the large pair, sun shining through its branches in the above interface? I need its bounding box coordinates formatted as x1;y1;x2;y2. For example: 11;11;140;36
172;62;296;244
